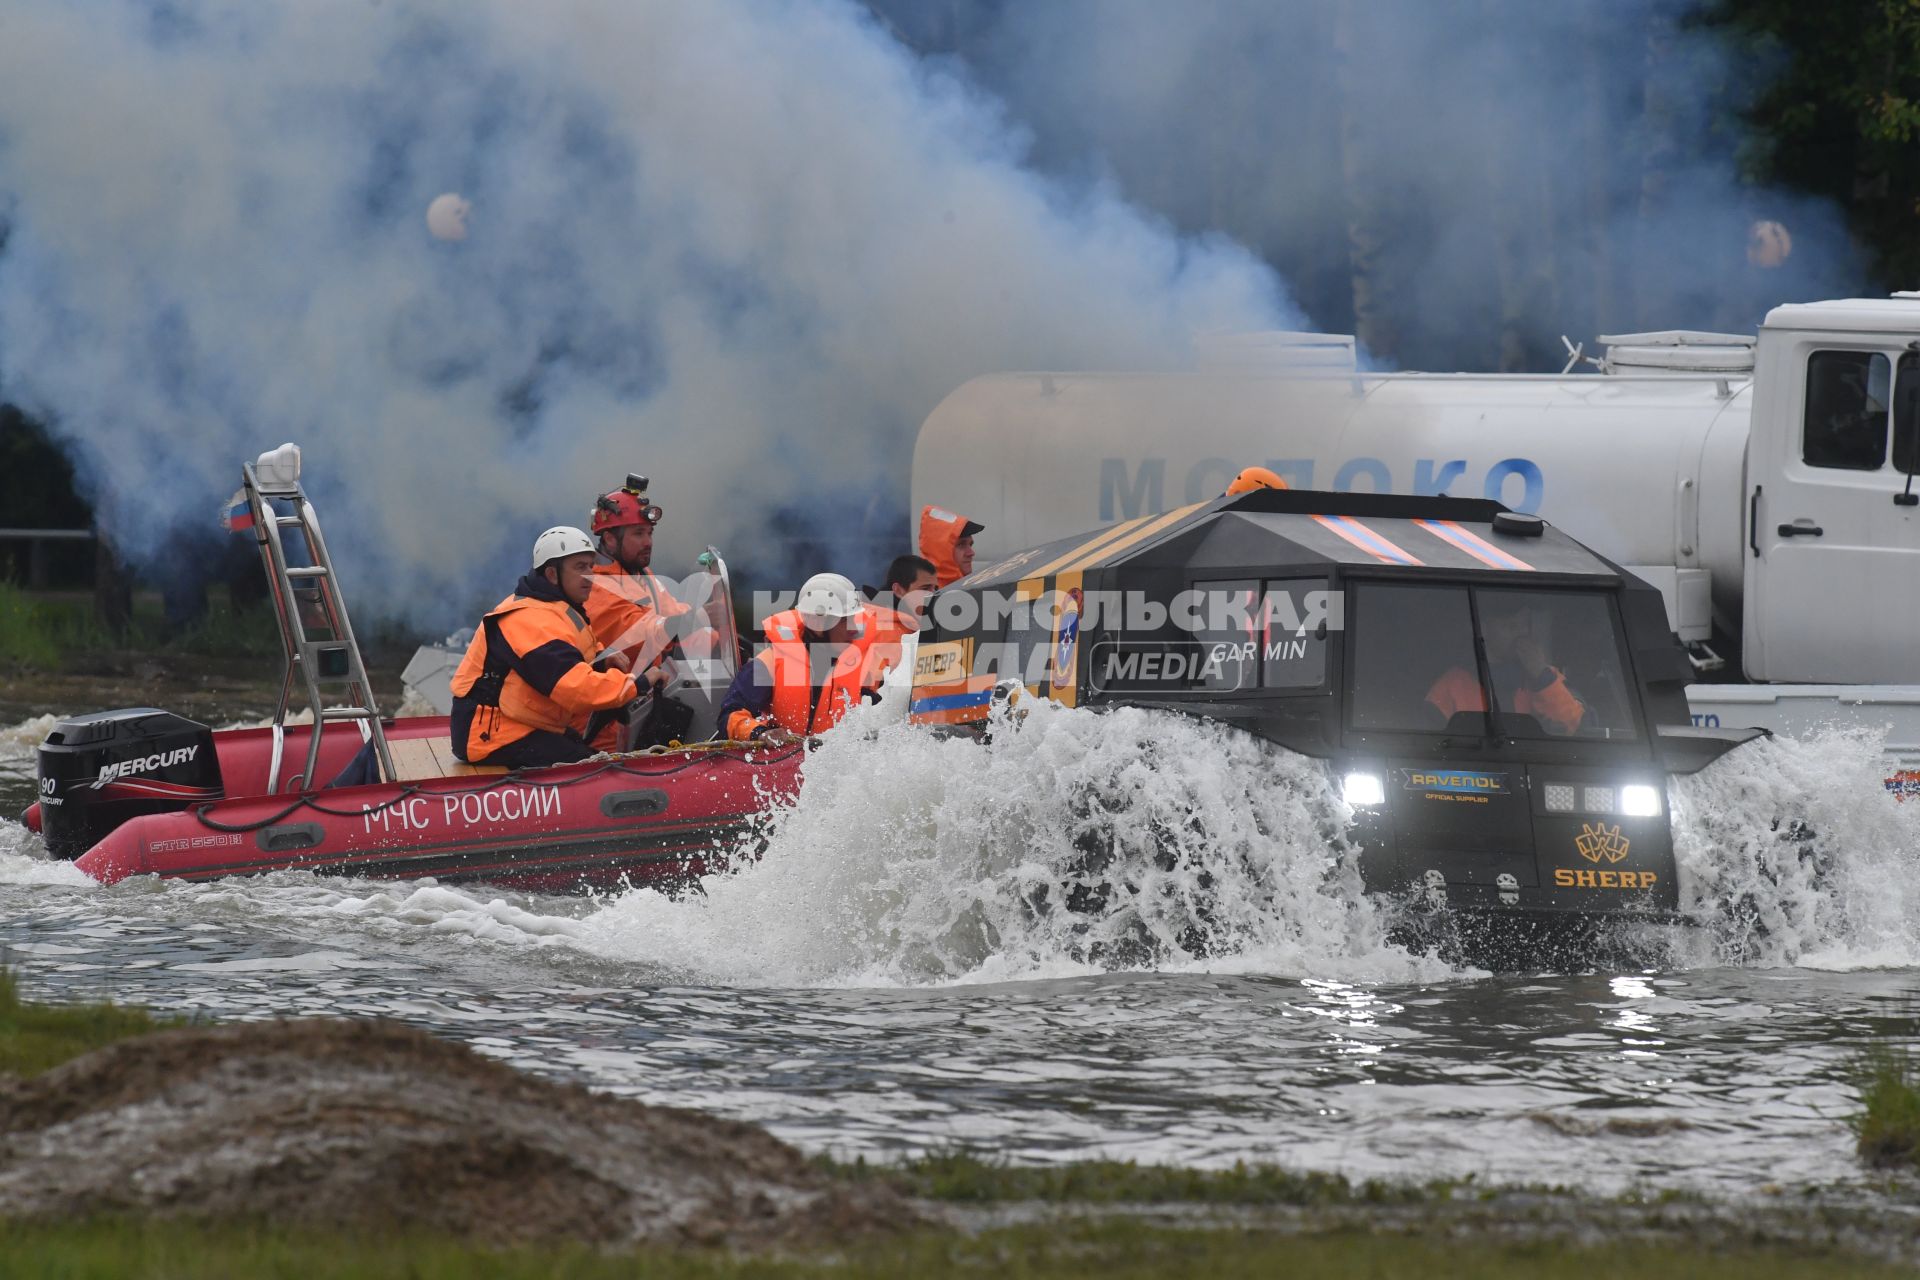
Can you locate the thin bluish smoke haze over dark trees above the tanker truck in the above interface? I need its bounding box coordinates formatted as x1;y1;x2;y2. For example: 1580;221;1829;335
870;0;1864;372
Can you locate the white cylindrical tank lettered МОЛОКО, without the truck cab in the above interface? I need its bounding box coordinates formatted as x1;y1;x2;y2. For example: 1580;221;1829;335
912;372;1751;616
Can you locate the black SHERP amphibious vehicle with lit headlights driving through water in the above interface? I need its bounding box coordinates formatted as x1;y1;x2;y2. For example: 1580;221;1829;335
910;489;1761;948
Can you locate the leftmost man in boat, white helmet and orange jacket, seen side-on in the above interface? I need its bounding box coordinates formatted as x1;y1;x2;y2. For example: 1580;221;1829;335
451;526;657;770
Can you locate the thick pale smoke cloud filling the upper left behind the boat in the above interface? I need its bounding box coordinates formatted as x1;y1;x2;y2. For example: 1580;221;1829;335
0;0;1302;624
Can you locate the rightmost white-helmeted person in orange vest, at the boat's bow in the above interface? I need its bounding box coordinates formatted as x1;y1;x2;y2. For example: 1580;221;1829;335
720;574;866;741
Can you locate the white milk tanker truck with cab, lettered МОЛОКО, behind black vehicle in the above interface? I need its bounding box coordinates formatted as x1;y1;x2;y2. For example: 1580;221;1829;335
912;294;1920;771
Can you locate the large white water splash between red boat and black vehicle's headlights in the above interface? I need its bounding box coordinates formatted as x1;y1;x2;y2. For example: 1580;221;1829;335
556;702;1450;984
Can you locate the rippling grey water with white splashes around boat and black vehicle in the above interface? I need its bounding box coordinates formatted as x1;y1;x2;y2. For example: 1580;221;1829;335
0;671;1920;1197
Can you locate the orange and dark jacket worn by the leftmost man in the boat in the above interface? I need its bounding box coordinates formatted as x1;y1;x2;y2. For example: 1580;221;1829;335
453;593;636;764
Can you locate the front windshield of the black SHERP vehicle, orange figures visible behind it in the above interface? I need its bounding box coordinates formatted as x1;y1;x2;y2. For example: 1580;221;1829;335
1350;583;1634;739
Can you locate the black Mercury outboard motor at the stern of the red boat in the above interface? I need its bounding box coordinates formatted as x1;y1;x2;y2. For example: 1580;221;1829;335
40;706;223;858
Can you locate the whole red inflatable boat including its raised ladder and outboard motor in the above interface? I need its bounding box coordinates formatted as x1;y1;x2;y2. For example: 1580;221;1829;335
25;445;804;890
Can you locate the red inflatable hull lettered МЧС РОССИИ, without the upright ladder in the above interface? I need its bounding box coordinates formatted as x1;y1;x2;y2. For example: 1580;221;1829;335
25;710;804;892
